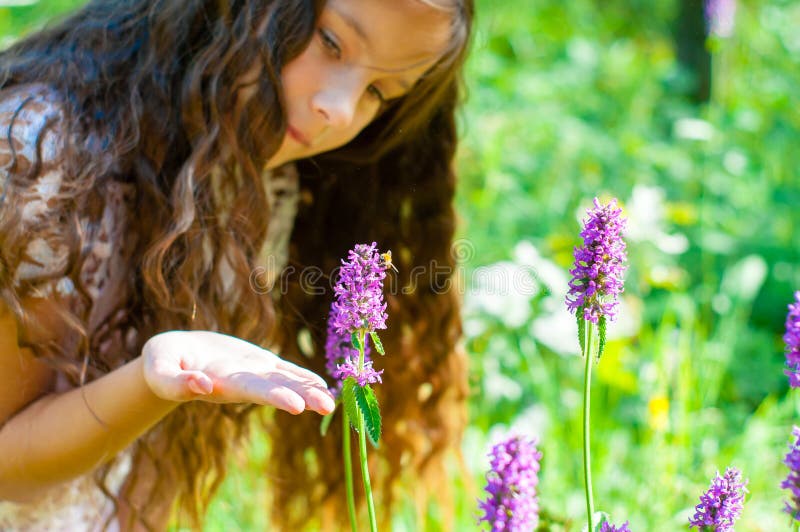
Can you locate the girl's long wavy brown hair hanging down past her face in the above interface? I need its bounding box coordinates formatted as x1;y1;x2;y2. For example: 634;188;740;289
0;0;473;529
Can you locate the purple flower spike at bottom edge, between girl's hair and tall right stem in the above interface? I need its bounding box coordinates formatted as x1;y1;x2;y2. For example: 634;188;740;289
478;436;542;532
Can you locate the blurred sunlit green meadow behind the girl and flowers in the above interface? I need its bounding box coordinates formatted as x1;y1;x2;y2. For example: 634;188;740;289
0;0;800;531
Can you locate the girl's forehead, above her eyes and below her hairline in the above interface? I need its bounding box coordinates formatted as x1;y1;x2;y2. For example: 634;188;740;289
324;0;452;72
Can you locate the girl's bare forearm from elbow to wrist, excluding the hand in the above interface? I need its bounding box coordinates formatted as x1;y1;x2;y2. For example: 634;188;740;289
0;357;179;502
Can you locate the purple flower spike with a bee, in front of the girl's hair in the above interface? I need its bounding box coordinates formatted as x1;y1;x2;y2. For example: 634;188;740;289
332;242;386;335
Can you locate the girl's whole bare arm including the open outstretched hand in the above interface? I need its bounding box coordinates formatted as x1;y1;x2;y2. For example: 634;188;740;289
0;306;334;502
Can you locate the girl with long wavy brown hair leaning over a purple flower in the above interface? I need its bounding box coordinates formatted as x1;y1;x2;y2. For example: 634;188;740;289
0;0;473;530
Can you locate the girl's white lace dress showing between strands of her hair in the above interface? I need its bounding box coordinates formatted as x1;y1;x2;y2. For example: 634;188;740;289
0;85;299;531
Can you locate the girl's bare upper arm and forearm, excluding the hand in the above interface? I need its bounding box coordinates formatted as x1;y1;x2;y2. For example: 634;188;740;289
0;304;179;502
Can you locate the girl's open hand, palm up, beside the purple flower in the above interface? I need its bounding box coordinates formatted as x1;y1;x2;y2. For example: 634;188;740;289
142;331;334;415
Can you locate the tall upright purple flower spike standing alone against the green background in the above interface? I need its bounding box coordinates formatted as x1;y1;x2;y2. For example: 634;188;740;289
567;198;627;324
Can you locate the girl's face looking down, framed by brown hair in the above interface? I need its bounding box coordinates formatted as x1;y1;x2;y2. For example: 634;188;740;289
268;0;450;168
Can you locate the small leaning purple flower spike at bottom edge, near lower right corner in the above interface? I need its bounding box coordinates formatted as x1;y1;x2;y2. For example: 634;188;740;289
689;467;747;532
